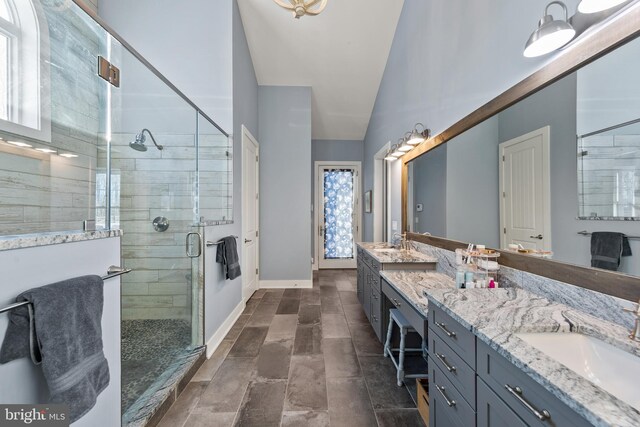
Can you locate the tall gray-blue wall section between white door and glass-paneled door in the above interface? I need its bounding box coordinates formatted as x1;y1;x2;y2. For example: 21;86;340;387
258;86;311;281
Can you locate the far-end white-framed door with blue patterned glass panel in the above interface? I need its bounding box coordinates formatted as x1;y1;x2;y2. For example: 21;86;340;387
316;162;360;268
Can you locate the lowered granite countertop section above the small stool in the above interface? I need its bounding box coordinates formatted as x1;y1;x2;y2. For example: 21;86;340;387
380;270;456;316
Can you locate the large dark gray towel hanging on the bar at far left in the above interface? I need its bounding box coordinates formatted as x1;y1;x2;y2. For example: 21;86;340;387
0;276;109;422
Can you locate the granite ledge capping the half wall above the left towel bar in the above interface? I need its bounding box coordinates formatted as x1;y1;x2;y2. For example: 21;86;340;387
0;230;122;251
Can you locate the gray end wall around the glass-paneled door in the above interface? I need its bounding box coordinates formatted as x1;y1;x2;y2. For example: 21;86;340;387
311;139;362;257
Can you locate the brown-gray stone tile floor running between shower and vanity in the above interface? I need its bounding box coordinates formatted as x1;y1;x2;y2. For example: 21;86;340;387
159;270;424;427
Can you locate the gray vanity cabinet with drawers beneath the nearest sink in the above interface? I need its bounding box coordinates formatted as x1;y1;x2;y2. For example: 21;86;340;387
429;305;591;427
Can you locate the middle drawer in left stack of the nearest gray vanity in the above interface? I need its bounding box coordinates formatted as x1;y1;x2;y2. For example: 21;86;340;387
429;334;476;408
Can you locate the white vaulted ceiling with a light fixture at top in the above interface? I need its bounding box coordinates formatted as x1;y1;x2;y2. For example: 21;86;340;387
238;0;404;140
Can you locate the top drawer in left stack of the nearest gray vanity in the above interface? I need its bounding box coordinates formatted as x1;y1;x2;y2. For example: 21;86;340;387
429;305;476;369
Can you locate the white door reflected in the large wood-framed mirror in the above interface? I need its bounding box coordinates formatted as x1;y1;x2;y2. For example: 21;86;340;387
500;126;551;250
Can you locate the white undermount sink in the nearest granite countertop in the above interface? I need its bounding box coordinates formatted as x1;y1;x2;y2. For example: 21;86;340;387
516;332;640;411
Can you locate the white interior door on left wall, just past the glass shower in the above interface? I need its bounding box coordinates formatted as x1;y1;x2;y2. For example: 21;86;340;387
241;126;260;301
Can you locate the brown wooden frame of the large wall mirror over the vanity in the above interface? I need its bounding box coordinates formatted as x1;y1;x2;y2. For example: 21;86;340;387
401;3;640;302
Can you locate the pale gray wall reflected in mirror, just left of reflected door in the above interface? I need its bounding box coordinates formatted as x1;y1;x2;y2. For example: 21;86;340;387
446;117;500;248
